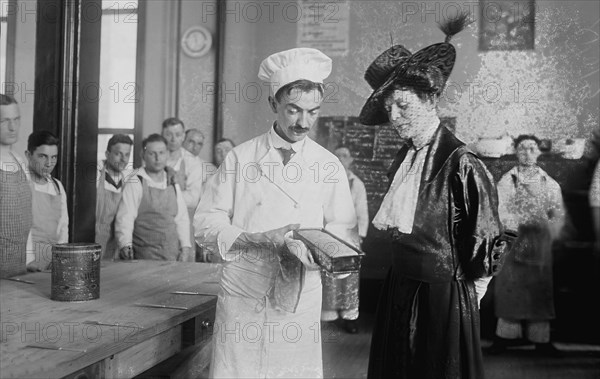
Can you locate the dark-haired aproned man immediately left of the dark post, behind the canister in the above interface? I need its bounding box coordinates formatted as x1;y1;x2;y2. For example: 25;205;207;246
25;131;69;271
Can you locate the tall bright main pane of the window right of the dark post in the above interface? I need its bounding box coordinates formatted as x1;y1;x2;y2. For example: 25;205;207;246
98;11;137;129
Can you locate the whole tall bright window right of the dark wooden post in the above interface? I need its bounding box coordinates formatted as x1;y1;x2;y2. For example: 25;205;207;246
98;0;138;166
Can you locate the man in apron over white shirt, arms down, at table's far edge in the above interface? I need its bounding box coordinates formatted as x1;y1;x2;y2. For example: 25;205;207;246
115;134;191;261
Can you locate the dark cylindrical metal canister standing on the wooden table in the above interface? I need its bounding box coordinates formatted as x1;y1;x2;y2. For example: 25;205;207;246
50;243;102;301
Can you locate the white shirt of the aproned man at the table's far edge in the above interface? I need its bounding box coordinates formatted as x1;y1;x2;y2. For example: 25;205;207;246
115;169;191;249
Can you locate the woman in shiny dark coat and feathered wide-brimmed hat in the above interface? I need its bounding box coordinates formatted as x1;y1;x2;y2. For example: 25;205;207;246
360;17;505;379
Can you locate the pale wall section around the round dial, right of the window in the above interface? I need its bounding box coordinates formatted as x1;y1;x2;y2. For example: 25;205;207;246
138;0;217;161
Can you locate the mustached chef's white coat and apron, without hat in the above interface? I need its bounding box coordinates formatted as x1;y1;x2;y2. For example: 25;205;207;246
194;128;356;378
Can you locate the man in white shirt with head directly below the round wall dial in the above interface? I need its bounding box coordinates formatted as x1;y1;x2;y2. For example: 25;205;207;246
162;117;206;261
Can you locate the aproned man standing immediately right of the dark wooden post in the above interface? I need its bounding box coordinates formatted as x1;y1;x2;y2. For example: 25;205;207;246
95;134;133;260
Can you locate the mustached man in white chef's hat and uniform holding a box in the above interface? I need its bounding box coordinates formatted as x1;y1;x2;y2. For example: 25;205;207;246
194;48;356;378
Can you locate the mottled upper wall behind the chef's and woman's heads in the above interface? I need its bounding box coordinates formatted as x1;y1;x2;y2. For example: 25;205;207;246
220;0;600;147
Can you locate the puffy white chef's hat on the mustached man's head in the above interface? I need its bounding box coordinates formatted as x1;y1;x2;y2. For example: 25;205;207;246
258;47;332;95
